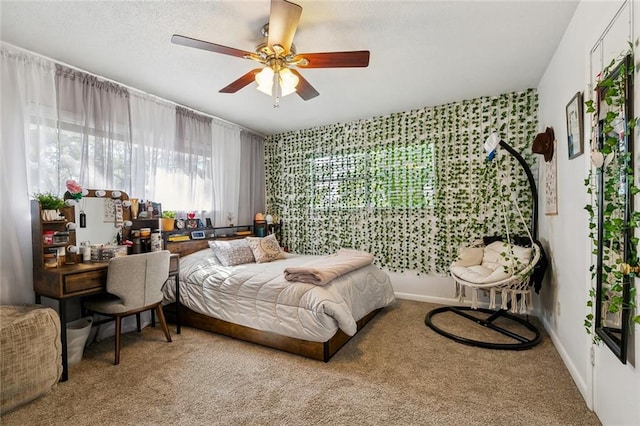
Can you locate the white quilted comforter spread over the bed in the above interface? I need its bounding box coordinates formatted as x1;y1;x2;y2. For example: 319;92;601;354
164;249;395;342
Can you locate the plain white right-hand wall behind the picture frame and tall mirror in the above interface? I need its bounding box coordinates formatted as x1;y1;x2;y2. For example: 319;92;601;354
537;0;640;425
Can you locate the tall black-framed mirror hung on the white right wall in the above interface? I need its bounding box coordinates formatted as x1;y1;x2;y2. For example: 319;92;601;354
594;55;638;363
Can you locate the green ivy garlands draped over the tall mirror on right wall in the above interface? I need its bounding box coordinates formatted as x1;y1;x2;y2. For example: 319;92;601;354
584;46;640;343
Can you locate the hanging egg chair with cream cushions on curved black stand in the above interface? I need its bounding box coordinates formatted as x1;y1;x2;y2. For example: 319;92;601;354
425;133;547;350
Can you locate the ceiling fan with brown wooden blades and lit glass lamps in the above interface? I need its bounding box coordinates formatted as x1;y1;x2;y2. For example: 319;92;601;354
171;0;369;108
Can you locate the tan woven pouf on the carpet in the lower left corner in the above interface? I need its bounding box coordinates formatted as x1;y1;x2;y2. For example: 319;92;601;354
0;305;62;414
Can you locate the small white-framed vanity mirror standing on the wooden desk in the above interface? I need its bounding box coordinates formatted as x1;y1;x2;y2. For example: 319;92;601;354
64;189;131;244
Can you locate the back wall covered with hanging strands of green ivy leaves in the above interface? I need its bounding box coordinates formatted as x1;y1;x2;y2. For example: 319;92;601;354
265;89;538;274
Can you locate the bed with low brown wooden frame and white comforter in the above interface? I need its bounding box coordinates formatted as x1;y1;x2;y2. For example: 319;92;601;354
164;238;395;362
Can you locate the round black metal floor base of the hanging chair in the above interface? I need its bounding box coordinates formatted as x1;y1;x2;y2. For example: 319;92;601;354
424;306;541;351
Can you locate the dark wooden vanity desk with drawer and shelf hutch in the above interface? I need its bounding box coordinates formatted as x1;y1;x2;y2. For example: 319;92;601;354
31;191;180;382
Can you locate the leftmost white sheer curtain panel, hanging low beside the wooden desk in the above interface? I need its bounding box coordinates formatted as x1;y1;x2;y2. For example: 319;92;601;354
0;44;58;304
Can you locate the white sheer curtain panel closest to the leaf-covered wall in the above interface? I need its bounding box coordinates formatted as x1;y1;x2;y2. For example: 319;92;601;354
211;120;241;226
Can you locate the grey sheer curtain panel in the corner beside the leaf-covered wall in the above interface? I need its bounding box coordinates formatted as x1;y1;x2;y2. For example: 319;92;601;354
237;130;266;225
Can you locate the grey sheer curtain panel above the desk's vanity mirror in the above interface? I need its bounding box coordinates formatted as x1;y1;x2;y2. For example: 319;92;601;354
56;65;132;192
